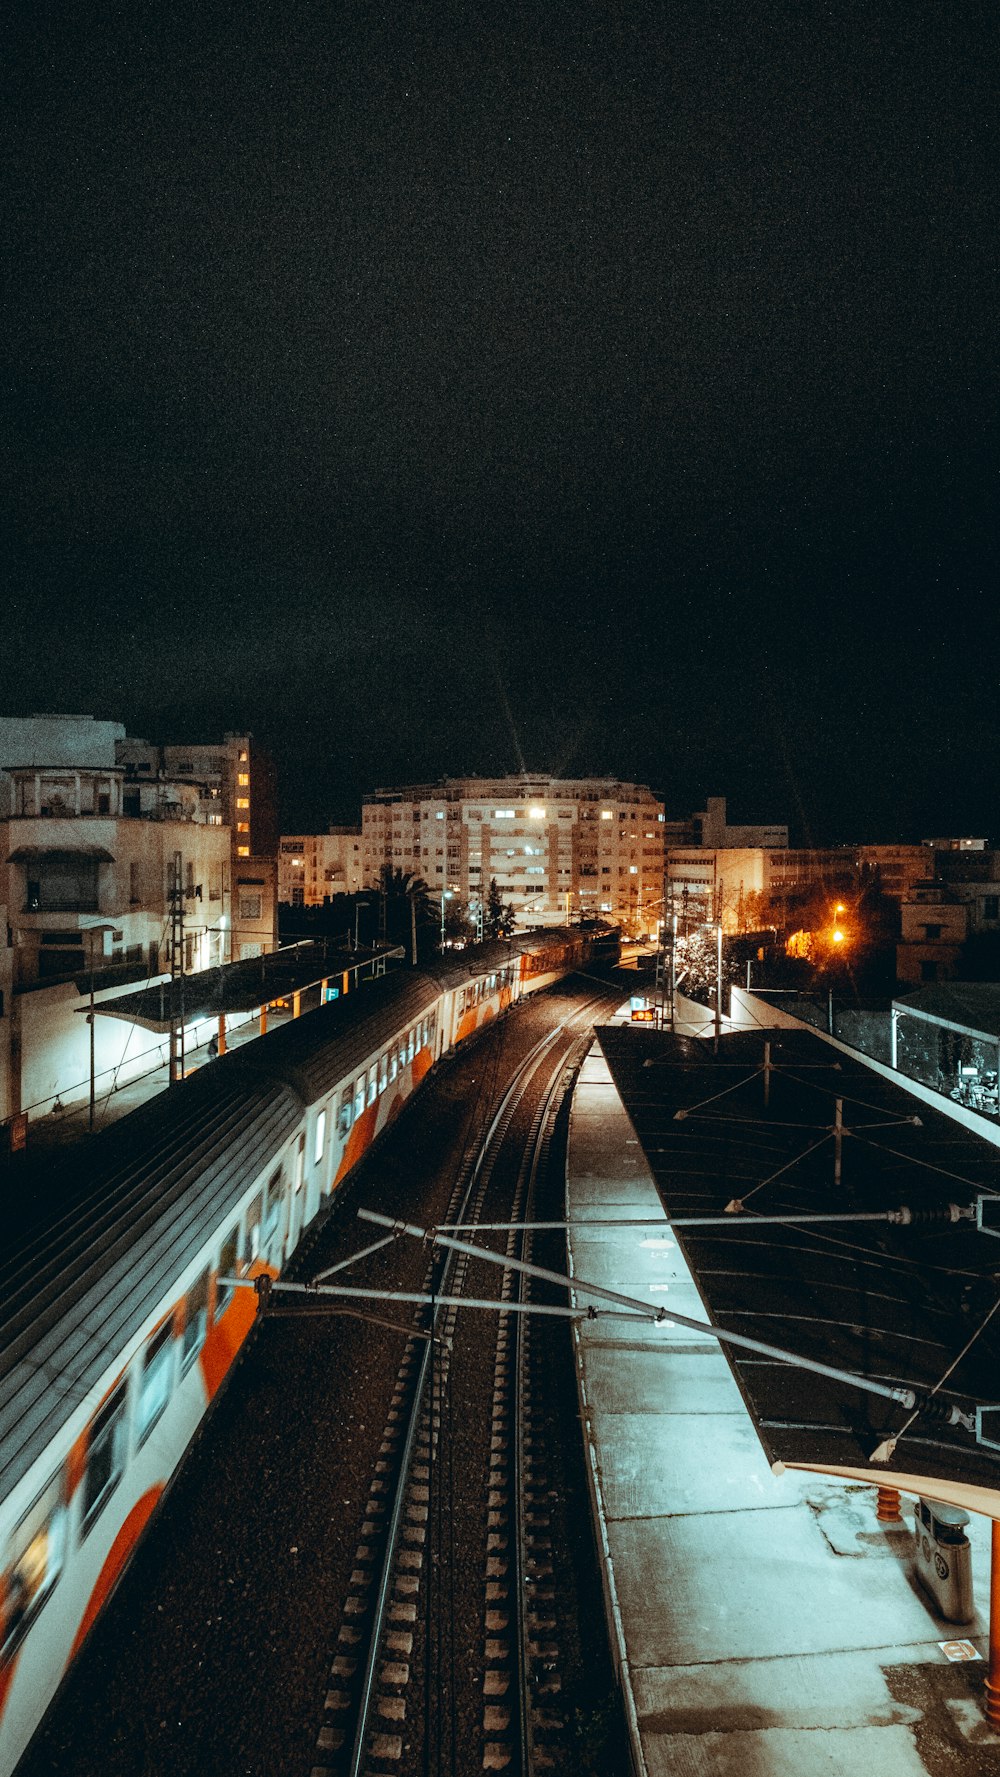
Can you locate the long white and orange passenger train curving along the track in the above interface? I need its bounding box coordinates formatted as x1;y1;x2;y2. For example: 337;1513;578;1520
0;929;599;1777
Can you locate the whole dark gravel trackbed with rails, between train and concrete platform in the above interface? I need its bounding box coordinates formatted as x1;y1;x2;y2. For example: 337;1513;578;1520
18;979;627;1777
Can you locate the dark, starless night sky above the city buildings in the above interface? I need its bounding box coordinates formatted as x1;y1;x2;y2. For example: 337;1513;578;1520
0;0;1000;842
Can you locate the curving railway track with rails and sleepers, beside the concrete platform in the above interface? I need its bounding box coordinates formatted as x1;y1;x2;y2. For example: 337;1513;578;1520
311;1008;611;1777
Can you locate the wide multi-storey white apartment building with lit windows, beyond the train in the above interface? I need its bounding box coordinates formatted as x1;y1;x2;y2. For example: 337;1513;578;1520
362;773;664;931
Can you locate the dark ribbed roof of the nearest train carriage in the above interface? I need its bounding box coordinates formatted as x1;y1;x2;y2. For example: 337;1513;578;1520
0;1068;302;1498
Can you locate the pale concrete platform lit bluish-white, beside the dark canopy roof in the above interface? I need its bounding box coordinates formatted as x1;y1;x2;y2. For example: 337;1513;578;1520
567;1045;1000;1777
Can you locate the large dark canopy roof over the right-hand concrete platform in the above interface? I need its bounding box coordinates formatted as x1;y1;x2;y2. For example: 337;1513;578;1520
597;1025;1000;1518
